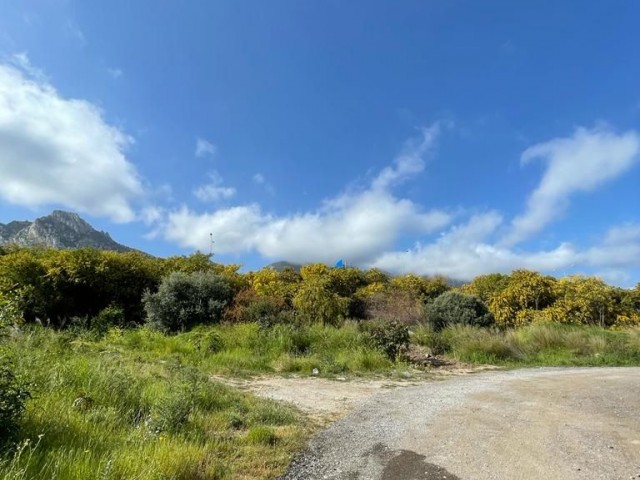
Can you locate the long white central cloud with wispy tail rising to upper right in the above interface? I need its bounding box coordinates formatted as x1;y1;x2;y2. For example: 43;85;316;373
164;128;451;262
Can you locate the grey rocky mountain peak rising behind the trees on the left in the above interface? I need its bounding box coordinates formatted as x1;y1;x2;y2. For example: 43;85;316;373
0;210;133;252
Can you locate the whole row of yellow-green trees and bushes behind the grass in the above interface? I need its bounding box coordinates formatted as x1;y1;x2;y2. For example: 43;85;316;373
0;247;640;331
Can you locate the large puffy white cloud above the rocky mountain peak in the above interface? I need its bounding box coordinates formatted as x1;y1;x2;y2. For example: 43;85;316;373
0;54;143;222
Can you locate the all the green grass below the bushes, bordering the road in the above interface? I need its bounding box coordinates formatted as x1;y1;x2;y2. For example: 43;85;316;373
0;322;640;480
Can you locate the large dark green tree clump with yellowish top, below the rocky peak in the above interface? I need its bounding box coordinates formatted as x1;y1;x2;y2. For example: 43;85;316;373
0;248;161;327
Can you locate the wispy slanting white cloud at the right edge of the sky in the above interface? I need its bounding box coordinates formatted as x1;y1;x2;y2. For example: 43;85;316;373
503;127;640;245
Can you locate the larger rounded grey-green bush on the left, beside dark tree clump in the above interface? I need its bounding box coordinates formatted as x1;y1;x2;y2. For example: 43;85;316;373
143;272;233;332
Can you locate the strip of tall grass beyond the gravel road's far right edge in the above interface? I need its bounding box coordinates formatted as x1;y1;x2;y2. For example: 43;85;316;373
412;324;640;367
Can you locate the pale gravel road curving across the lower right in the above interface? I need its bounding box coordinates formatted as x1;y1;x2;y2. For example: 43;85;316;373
283;368;640;480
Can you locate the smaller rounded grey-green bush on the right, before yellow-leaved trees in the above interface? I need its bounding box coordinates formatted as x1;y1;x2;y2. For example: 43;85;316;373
426;291;495;330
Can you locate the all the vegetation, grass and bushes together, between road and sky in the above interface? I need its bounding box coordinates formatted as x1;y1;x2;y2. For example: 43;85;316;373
0;247;640;480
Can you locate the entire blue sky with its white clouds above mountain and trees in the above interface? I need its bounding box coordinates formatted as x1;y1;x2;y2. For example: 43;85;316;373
0;0;640;286
